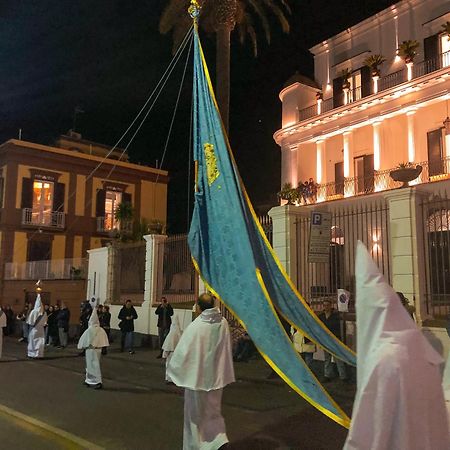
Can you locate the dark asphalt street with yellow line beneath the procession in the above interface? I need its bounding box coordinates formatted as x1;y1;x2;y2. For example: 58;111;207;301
0;338;354;450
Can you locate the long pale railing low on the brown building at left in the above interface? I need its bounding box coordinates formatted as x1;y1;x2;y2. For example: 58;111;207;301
5;258;87;280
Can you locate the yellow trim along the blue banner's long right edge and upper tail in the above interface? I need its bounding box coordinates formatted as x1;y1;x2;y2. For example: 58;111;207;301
196;30;356;359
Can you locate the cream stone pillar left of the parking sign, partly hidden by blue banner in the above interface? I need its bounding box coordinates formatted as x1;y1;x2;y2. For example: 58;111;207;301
269;205;308;285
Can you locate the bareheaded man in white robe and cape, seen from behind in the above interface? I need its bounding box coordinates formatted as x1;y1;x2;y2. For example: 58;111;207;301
167;294;235;450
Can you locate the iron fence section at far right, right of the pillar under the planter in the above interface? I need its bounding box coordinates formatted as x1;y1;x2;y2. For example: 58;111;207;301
421;193;450;318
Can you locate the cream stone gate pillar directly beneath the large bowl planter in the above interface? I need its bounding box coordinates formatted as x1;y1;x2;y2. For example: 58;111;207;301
383;187;427;325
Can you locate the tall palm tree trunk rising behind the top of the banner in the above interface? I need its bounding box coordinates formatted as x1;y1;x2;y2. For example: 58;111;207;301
216;24;232;133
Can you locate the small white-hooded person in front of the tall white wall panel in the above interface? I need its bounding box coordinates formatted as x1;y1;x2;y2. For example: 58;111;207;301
78;299;109;389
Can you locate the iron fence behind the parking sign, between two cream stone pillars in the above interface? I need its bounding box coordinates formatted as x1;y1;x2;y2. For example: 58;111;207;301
296;198;391;311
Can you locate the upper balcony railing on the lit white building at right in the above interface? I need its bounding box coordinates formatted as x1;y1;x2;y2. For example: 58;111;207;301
298;51;450;122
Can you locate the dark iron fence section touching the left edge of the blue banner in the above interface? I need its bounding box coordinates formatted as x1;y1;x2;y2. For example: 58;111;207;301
159;234;198;303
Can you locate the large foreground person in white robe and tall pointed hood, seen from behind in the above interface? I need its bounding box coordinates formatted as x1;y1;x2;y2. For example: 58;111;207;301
344;242;450;450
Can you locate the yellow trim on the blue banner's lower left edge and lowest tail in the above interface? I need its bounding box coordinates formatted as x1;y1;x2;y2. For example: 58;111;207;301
191;256;350;429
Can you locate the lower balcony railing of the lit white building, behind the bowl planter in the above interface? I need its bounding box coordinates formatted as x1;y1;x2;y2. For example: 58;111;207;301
299;158;450;205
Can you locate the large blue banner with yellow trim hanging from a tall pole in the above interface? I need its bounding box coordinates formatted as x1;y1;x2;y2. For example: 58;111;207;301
189;30;355;427
